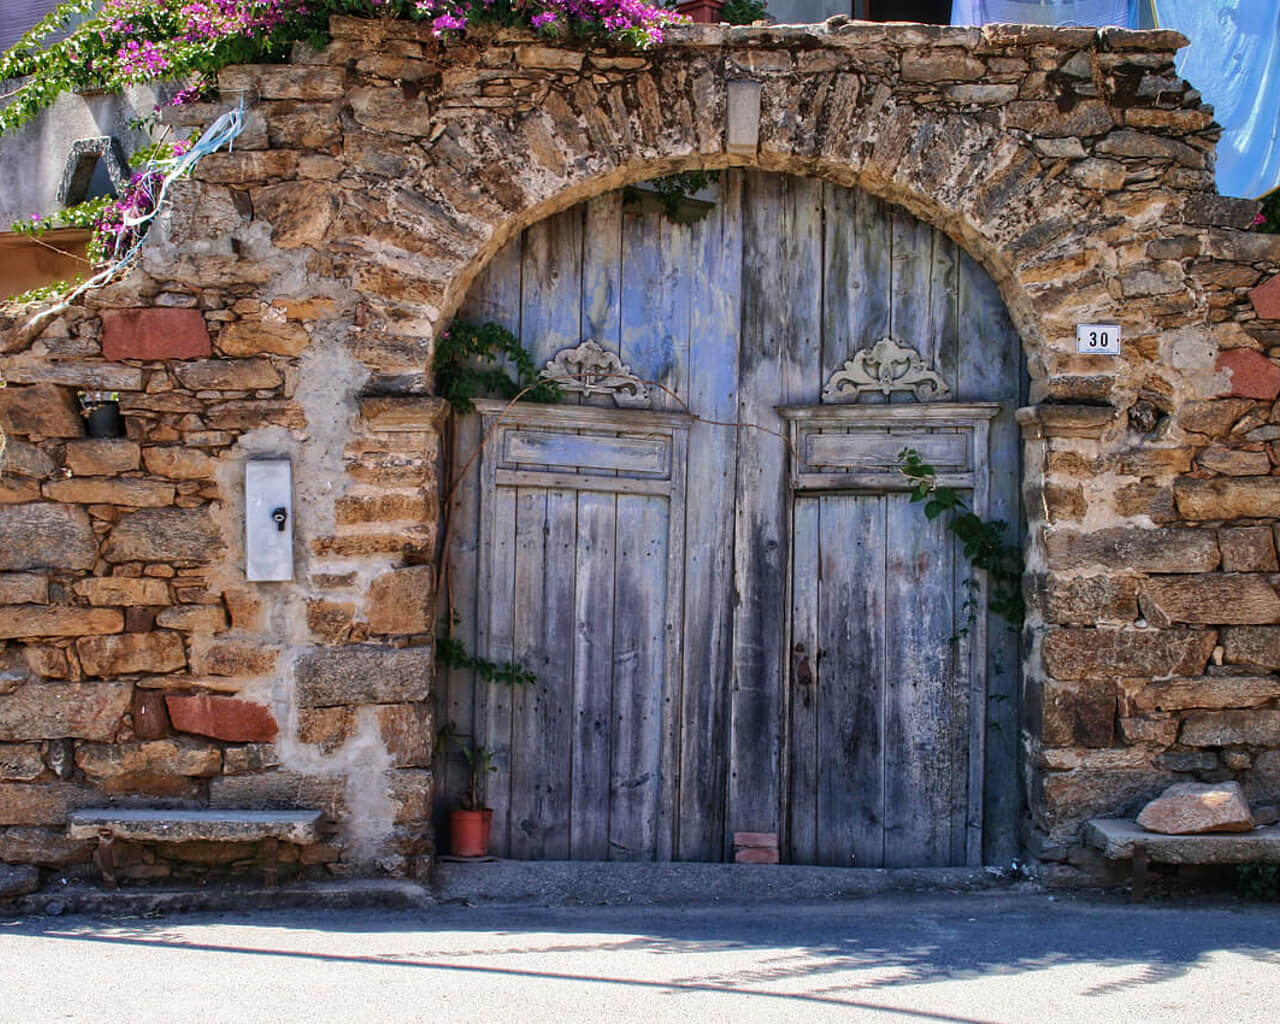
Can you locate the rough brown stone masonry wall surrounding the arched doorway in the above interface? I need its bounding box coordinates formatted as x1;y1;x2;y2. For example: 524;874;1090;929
0;18;1280;877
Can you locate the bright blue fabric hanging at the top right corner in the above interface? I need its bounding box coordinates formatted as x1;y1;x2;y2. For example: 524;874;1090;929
1155;0;1280;197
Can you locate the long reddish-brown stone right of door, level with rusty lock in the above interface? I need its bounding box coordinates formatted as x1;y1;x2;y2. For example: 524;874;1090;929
1043;628;1217;680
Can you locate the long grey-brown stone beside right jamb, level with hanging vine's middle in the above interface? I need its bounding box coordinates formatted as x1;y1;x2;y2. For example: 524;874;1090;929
1044;526;1219;572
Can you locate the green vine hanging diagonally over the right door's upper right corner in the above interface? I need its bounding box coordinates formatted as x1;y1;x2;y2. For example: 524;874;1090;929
897;448;1027;627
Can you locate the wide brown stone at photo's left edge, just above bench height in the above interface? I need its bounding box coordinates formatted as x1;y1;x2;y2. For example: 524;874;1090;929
0;682;133;742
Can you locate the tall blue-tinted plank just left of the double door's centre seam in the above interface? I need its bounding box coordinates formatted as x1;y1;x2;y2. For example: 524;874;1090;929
676;170;742;860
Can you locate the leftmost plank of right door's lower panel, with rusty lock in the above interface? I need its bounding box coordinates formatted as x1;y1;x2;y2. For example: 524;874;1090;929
787;497;819;864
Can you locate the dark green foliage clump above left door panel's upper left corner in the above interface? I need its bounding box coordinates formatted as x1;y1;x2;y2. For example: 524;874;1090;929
431;320;563;413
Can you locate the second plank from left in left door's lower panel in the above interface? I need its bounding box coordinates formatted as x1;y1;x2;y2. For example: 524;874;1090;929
506;488;547;860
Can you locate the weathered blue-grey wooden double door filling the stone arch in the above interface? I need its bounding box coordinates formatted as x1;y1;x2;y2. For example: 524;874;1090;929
438;172;1024;867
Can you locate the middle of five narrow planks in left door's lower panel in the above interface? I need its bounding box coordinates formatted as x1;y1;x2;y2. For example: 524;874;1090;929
535;490;577;860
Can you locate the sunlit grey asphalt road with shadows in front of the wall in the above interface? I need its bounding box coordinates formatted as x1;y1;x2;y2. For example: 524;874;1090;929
0;893;1280;1024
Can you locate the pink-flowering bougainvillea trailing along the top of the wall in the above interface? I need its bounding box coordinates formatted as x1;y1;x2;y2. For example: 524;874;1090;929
0;0;685;134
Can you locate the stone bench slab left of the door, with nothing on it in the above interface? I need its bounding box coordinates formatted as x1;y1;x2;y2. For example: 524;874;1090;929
67;808;324;844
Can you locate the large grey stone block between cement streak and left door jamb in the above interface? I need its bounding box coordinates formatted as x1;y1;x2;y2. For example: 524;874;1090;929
296;644;433;708
